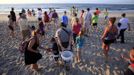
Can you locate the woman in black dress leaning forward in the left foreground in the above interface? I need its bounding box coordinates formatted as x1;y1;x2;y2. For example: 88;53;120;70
24;30;42;70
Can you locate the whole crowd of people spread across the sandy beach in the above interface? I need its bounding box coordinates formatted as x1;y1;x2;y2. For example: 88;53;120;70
8;6;134;74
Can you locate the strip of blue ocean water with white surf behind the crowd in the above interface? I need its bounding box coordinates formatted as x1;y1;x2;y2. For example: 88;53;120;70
0;4;134;13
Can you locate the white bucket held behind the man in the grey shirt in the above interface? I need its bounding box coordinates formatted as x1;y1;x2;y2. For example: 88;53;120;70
61;51;73;62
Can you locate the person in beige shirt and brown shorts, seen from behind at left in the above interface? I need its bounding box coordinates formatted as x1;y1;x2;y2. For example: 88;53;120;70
18;13;30;41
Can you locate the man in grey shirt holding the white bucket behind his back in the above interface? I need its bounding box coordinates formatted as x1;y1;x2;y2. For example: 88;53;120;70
55;23;72;51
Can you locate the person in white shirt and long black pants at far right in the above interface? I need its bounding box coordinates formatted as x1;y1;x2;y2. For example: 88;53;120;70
117;13;130;43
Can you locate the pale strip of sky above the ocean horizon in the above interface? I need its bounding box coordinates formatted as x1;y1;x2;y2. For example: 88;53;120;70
0;0;134;4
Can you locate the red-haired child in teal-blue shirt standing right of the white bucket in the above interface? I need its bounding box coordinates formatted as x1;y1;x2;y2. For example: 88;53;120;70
76;30;85;63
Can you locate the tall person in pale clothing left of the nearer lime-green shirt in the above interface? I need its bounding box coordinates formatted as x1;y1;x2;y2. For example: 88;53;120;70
84;8;92;35
